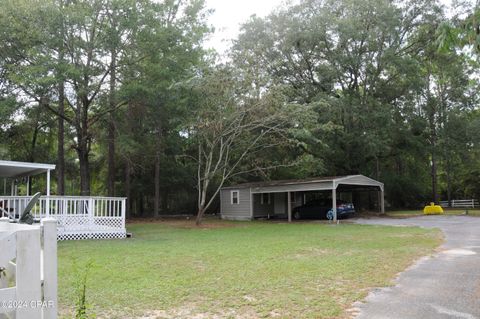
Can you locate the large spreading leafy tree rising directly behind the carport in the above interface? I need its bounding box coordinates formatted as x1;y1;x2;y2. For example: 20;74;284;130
232;0;441;208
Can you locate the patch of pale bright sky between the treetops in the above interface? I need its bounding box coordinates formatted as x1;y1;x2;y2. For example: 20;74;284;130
205;0;284;53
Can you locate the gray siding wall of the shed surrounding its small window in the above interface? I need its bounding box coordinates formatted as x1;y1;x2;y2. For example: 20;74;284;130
220;188;252;220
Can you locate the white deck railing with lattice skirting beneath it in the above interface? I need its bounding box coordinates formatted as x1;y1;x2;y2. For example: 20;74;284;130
0;196;126;240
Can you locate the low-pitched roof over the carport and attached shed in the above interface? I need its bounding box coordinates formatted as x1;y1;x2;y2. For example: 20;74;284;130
223;175;383;193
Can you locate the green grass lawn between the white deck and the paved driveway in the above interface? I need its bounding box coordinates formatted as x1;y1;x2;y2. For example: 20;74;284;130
58;221;442;318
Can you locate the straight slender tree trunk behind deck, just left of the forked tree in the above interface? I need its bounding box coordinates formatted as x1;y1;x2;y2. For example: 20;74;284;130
55;81;65;195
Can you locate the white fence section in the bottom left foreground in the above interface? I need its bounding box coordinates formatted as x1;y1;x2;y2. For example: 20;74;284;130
0;218;58;319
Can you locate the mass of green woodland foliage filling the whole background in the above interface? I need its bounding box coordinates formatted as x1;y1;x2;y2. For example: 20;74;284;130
0;0;480;212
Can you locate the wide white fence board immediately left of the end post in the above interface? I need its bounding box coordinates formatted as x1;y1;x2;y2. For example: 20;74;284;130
16;228;42;319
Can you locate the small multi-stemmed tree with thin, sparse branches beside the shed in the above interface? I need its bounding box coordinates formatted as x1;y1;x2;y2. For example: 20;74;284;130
184;68;311;225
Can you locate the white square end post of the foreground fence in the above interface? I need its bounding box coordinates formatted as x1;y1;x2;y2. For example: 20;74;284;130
42;218;58;319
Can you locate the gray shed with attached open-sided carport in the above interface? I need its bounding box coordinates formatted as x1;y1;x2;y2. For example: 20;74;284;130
220;175;385;221
